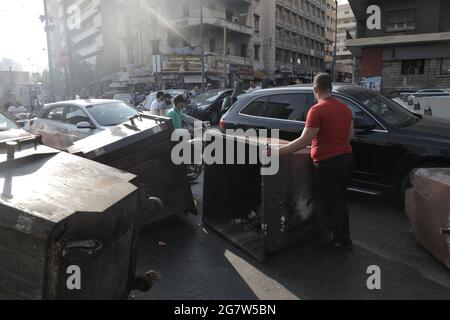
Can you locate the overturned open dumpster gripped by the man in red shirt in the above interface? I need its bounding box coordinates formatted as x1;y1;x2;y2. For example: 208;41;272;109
203;134;327;262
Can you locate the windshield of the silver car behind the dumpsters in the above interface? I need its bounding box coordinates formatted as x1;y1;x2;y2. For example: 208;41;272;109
87;102;138;127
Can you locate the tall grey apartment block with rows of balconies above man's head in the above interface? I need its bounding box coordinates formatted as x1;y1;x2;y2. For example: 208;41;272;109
264;0;326;85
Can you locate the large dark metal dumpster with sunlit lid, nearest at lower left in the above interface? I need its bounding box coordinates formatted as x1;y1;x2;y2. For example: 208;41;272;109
0;138;158;299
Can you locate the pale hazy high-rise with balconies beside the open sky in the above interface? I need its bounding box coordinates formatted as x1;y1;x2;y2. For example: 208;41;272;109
46;0;121;98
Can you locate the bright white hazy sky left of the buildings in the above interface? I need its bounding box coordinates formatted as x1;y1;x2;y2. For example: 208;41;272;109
0;0;348;71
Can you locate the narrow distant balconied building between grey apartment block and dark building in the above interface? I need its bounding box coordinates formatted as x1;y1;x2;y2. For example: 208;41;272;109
336;4;356;82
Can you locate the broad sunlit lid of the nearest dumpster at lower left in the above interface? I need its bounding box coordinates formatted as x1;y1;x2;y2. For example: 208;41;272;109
0;152;136;223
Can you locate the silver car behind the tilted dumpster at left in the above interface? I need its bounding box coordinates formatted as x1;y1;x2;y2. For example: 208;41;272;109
31;100;138;150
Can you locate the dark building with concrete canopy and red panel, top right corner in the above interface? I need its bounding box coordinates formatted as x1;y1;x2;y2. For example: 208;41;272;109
347;0;450;93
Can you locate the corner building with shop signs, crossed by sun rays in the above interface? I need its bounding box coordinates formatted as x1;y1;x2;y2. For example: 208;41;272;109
132;0;262;88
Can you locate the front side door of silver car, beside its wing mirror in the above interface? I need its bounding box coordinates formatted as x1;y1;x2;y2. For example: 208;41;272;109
64;106;97;147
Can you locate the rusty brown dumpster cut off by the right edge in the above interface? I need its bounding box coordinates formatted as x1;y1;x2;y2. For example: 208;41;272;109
406;168;450;268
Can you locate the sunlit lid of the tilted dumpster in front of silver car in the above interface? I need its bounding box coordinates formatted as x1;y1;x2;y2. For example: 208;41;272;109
67;115;171;159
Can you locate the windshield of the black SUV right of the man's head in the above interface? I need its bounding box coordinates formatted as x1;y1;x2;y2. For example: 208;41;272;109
340;88;420;127
